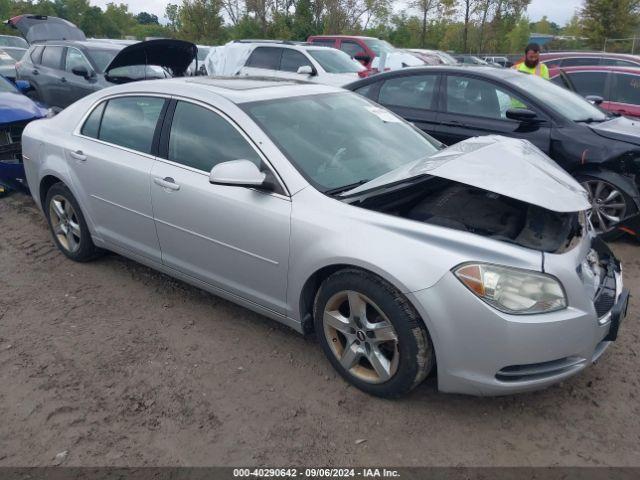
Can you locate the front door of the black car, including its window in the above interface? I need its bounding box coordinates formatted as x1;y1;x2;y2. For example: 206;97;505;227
434;74;551;153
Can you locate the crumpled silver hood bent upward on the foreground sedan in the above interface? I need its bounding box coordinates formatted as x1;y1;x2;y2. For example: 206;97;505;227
343;135;591;212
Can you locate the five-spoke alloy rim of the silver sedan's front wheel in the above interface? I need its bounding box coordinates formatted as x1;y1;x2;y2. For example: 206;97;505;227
323;290;399;383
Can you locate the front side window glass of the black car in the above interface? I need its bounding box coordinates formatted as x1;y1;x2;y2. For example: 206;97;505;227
447;75;530;120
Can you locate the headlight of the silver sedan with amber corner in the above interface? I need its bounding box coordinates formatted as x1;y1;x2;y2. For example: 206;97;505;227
453;263;567;315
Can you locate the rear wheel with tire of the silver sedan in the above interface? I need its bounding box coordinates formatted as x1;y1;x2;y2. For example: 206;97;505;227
44;183;100;262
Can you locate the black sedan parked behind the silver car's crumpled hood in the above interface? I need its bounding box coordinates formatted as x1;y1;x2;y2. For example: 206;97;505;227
345;67;640;239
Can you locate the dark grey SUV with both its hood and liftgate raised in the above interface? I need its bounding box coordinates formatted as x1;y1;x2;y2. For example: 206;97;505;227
7;15;197;108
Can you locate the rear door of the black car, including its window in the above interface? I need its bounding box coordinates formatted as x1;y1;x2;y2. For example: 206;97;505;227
376;73;441;136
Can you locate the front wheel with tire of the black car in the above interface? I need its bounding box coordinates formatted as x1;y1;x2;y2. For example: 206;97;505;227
578;175;635;240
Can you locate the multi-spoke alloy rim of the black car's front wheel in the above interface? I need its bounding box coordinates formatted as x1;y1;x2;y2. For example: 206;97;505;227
582;180;627;234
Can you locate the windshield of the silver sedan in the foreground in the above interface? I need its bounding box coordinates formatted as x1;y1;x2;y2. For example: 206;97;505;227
243;93;437;193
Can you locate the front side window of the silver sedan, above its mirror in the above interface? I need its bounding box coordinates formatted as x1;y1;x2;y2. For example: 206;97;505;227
169;102;262;172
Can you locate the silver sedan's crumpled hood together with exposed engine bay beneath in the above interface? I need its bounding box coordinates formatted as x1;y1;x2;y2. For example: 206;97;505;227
345;137;590;253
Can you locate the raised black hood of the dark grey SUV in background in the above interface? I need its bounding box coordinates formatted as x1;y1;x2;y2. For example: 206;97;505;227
105;39;198;83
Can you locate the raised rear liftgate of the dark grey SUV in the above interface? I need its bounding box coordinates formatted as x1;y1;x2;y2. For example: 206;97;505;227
5;14;87;43
